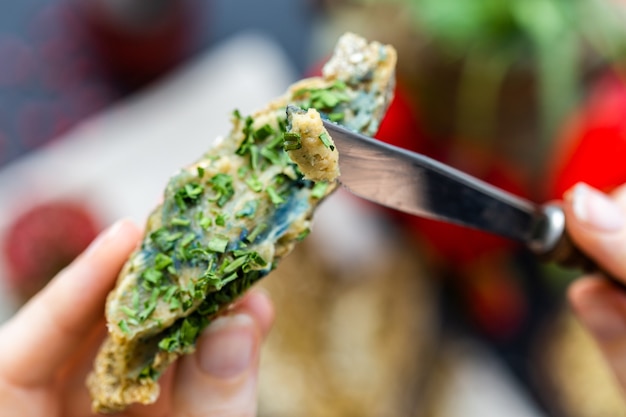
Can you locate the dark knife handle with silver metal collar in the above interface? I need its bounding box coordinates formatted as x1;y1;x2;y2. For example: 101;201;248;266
531;204;626;290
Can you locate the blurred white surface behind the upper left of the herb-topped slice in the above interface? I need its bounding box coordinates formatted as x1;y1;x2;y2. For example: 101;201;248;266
0;34;295;321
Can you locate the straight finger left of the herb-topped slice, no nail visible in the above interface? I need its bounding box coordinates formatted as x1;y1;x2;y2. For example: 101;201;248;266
0;220;140;385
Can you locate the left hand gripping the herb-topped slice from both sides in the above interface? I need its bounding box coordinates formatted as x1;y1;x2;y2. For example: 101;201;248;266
0;221;274;417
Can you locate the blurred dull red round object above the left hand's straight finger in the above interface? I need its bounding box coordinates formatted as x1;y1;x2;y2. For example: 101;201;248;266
2;201;100;301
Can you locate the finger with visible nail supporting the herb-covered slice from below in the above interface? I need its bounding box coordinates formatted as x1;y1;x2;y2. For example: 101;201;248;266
173;292;274;417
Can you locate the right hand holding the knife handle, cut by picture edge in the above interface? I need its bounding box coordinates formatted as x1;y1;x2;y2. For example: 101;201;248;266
564;184;626;393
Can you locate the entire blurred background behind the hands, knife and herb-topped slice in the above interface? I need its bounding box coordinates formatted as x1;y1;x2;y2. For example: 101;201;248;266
0;0;626;417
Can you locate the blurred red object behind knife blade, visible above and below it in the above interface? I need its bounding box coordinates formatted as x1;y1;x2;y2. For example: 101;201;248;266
376;86;529;340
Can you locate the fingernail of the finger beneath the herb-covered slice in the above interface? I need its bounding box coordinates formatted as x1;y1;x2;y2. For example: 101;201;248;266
199;314;257;378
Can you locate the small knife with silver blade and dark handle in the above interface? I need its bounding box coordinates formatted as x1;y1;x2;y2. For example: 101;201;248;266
323;120;599;272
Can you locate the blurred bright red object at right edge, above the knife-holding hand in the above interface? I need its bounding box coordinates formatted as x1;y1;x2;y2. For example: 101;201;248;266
547;74;626;199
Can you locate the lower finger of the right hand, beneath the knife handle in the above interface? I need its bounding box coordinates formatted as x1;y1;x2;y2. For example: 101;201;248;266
568;276;626;391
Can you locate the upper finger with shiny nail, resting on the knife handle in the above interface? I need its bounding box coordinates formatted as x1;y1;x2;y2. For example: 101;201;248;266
563;183;626;283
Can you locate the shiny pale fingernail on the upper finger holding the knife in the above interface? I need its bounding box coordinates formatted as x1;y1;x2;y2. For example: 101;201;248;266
571;183;625;232
